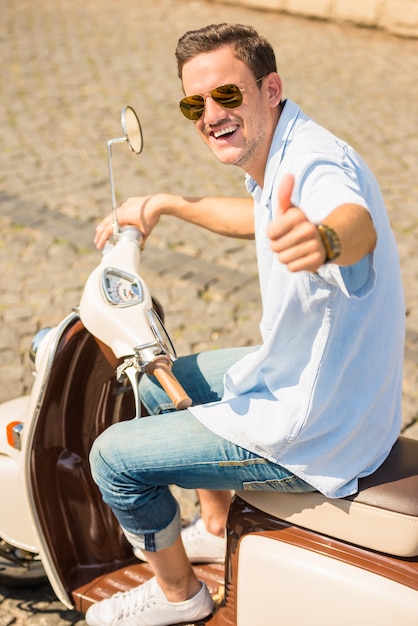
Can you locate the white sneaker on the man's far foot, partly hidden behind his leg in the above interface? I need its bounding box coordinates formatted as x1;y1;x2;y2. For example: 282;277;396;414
134;517;226;563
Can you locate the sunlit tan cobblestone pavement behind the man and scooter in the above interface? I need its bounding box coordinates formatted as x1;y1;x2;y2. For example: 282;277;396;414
0;0;418;626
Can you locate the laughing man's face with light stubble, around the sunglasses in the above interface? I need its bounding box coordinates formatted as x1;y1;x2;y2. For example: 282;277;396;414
182;46;281;184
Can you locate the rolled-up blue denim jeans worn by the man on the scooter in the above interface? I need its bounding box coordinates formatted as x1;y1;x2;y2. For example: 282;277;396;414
90;348;314;551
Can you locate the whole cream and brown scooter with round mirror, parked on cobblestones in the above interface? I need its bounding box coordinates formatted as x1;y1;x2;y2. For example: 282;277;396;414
0;107;418;626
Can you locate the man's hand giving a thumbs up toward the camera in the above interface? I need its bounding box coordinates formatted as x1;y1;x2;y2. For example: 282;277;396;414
267;174;326;272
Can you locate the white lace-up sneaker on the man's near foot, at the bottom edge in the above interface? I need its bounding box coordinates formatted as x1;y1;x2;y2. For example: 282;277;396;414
86;578;213;626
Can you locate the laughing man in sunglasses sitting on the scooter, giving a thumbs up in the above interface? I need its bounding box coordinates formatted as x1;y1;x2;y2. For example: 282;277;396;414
86;24;405;626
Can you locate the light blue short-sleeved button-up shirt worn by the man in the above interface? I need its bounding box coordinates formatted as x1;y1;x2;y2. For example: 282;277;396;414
190;100;405;497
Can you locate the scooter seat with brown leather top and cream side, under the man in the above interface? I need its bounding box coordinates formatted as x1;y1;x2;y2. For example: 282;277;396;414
238;437;418;557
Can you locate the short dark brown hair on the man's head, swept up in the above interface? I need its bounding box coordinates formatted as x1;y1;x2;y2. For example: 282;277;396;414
176;24;277;79
